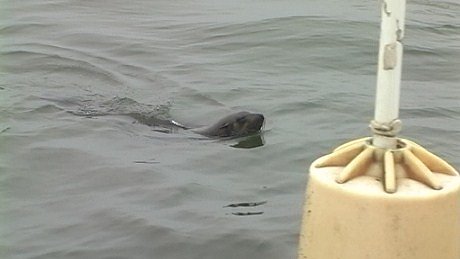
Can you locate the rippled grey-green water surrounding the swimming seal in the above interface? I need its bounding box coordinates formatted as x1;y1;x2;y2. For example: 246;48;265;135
0;0;460;259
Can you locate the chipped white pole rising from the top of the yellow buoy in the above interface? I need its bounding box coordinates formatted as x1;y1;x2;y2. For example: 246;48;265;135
371;0;406;149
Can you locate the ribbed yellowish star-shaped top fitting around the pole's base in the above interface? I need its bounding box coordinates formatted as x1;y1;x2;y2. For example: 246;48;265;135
316;138;459;193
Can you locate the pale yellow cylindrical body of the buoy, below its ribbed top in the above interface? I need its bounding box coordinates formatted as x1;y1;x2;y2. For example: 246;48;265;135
298;160;460;259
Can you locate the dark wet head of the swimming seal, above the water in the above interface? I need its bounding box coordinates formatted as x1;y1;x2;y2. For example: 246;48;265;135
196;112;265;138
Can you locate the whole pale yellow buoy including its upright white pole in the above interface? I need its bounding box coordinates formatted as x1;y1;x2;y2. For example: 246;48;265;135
298;0;460;259
